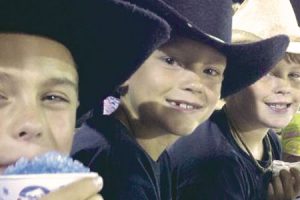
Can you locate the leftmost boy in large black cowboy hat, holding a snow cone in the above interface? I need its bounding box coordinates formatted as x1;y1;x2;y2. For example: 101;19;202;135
0;0;169;200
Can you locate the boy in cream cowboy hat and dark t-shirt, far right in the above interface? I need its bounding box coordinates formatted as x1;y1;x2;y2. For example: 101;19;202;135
168;0;300;200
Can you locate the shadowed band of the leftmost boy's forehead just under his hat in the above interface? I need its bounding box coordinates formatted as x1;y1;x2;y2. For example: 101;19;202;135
0;33;74;65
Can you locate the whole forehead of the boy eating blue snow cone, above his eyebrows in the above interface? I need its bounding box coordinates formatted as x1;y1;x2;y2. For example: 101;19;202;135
0;33;78;83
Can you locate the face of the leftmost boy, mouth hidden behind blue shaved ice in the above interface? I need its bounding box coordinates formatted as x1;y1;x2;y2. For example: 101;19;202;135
0;34;78;174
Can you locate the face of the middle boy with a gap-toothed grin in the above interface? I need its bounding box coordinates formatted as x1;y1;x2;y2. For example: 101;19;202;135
121;37;226;135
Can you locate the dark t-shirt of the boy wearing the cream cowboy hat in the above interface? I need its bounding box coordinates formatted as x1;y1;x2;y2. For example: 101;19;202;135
164;110;281;200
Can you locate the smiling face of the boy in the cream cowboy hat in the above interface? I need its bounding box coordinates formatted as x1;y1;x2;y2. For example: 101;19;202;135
227;54;300;128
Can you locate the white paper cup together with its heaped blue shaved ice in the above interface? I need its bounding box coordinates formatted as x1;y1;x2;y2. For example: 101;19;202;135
0;152;98;200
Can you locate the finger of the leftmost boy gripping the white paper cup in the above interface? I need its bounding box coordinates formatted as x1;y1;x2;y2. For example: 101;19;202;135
42;177;103;200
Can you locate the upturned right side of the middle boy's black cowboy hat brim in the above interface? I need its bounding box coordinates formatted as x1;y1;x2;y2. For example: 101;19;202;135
221;35;289;98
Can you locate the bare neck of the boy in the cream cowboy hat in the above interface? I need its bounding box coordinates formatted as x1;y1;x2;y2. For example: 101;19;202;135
226;105;269;160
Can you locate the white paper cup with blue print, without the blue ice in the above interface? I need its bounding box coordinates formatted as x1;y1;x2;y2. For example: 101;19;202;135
0;172;98;200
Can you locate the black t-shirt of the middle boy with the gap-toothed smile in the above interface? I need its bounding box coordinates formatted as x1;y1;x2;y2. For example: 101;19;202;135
72;115;171;200
